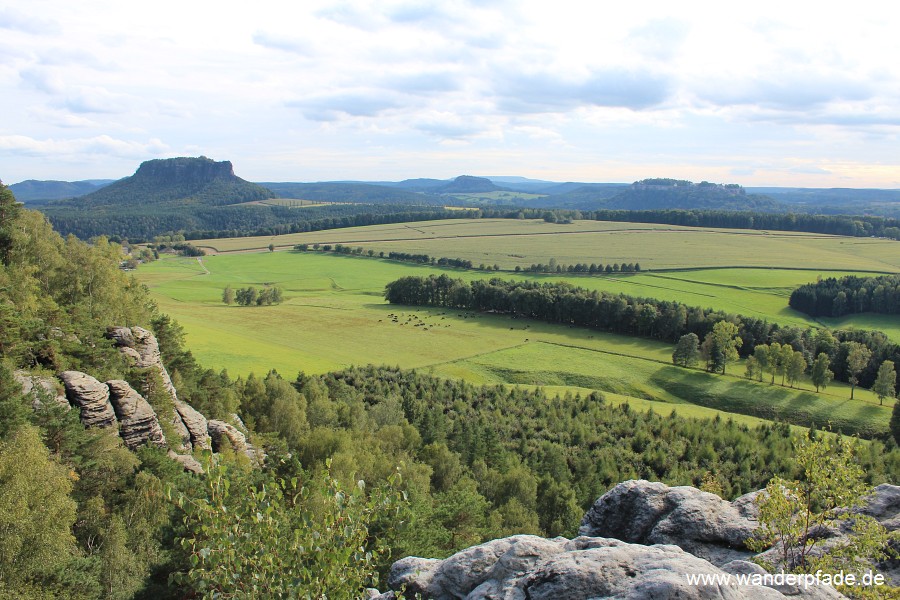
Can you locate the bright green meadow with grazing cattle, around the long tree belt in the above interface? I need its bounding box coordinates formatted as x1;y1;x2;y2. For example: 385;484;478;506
137;252;890;432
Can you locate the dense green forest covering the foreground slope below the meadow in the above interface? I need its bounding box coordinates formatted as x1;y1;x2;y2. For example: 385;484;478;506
0;180;900;600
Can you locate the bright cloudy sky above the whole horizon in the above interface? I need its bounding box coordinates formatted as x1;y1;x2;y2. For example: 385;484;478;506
0;0;900;188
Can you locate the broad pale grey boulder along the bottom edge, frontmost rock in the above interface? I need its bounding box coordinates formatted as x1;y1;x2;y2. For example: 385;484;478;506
379;535;843;600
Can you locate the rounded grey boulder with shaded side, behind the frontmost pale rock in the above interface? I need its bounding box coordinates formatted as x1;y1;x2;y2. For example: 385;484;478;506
578;480;759;565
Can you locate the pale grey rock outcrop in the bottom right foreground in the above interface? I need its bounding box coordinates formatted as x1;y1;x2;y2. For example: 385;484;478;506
371;481;900;600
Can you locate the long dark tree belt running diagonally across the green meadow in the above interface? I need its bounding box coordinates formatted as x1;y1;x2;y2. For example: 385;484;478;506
385;275;900;396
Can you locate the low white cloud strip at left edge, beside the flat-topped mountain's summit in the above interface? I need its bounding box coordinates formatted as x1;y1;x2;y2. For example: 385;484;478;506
0;135;170;159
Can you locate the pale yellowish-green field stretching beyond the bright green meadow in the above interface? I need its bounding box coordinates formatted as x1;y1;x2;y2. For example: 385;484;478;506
193;219;900;273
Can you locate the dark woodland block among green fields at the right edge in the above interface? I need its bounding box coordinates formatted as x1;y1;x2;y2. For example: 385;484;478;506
789;275;900;317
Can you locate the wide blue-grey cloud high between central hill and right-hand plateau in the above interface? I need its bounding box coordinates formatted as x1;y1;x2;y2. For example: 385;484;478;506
494;68;670;113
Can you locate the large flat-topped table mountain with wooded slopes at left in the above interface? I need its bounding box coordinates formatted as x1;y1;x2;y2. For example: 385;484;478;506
56;156;275;209
